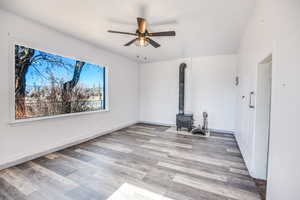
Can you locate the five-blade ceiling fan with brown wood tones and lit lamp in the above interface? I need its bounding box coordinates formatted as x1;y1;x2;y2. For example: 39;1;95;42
108;17;176;48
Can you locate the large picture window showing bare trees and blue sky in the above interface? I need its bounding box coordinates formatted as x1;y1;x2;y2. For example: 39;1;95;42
15;45;106;120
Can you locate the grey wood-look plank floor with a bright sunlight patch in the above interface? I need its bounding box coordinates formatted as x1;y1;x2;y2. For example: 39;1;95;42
0;124;260;200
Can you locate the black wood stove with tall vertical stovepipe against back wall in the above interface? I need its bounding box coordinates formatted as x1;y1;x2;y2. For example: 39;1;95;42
176;63;194;131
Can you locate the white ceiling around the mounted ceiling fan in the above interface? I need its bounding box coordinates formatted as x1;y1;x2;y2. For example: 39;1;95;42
0;0;255;62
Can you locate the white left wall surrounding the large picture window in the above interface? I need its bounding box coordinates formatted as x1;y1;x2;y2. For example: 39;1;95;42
0;10;139;169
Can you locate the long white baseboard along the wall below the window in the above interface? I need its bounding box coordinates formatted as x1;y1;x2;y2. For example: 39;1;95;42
0;121;138;170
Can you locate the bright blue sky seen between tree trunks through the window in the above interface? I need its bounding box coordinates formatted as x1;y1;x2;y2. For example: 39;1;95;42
26;50;104;89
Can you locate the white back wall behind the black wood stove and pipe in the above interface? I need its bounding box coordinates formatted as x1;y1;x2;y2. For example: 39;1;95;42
140;55;236;131
